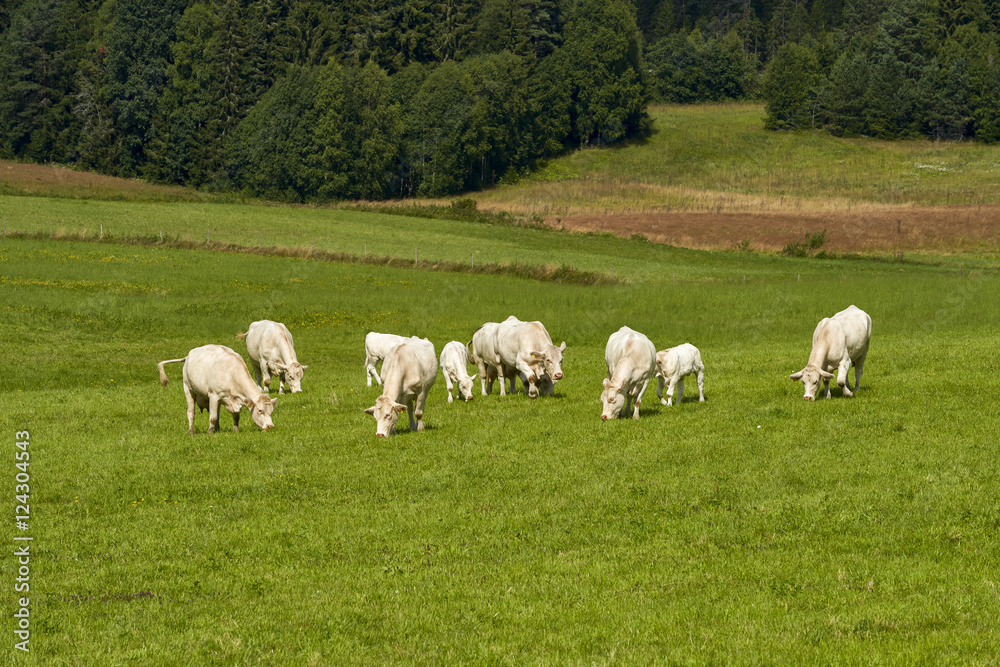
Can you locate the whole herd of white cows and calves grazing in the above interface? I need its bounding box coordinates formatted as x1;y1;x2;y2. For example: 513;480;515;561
158;305;872;437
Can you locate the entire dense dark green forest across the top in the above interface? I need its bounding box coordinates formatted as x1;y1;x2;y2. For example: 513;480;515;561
0;0;1000;201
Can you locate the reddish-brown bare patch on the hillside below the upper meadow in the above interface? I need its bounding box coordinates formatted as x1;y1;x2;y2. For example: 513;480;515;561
546;205;1000;253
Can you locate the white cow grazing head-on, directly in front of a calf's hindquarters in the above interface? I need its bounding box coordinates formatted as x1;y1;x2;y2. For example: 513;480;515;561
365;336;437;438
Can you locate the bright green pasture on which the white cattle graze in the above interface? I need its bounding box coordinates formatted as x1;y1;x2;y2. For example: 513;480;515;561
0;190;1000;665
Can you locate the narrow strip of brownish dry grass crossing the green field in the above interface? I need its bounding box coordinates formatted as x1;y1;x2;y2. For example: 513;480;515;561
5;232;623;286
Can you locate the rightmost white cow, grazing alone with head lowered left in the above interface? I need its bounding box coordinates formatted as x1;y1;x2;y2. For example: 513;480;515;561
788;306;872;401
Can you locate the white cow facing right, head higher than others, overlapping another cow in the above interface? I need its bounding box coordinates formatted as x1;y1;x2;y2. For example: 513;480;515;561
497;315;566;398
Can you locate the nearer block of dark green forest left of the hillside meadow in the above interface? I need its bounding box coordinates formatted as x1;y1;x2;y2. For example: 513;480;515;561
0;0;648;201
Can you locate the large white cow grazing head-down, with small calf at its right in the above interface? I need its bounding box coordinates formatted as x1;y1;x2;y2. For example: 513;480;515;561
601;327;656;420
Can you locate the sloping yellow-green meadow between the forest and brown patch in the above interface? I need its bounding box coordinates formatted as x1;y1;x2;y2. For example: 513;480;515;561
477;104;1000;216
